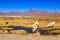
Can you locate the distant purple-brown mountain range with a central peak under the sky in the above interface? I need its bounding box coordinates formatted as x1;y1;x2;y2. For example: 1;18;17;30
0;9;60;16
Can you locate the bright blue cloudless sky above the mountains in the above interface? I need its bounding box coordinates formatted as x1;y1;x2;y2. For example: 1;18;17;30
0;0;60;12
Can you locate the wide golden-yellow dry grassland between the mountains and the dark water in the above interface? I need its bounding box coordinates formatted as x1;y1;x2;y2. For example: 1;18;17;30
0;16;60;27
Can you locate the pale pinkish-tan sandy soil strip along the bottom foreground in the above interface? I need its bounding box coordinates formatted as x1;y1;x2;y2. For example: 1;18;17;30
0;34;60;40
